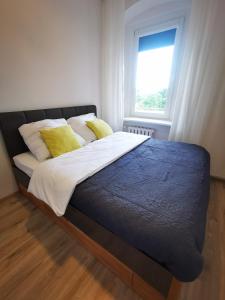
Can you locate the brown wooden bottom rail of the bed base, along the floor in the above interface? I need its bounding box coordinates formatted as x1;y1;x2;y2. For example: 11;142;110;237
19;184;181;300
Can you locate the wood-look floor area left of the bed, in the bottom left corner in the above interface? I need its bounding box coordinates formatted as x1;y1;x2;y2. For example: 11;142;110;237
0;194;140;300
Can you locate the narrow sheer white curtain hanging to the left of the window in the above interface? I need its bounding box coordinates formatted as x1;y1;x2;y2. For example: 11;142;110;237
101;0;125;130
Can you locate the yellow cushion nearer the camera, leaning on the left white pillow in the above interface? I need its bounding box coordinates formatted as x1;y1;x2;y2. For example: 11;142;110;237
40;125;81;157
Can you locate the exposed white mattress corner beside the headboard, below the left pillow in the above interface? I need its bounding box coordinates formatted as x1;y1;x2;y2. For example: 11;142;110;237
13;152;40;177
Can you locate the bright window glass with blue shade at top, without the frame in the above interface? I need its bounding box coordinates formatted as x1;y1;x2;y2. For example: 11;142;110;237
134;28;176;118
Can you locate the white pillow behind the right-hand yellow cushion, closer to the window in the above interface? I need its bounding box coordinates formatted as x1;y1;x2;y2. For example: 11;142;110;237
67;113;96;143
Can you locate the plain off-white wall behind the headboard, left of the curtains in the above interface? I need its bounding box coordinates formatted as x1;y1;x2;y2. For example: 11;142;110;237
0;0;101;198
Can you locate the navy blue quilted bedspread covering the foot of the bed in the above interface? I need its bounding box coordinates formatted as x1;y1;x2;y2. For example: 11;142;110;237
70;139;210;281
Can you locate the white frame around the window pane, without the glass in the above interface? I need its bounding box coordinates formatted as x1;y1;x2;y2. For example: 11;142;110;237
128;17;185;121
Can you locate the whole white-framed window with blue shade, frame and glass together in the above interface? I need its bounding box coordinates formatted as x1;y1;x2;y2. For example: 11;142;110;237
124;14;185;121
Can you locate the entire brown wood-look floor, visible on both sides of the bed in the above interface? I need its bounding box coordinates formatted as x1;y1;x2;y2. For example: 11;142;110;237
0;181;225;300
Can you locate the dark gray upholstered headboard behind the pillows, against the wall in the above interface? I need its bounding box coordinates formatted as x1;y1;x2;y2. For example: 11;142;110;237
0;105;97;158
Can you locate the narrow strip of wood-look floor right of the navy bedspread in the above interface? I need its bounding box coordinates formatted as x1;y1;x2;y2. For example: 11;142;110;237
180;180;225;300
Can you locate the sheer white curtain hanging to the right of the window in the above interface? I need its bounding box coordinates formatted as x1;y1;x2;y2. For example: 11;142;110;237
170;0;225;178
